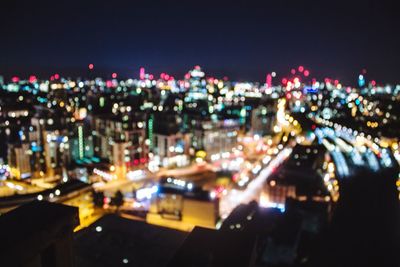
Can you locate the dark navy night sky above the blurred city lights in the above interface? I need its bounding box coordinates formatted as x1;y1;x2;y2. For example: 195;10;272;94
0;0;400;83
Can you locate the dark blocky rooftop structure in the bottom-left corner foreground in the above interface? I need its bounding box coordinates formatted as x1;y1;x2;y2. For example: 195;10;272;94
0;201;79;267
